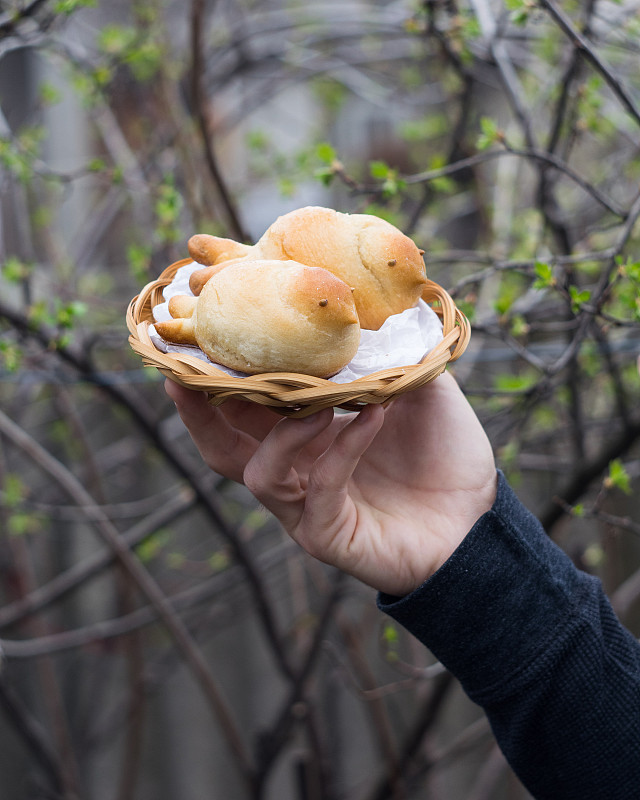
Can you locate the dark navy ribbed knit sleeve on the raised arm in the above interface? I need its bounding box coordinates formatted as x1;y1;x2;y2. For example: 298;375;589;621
378;475;640;800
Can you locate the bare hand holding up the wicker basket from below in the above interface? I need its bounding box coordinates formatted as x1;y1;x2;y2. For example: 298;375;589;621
165;373;496;596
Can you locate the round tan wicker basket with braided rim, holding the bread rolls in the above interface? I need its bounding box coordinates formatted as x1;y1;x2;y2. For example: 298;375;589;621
127;258;471;417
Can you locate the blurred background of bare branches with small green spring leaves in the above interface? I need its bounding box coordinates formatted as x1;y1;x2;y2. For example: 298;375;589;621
0;0;640;800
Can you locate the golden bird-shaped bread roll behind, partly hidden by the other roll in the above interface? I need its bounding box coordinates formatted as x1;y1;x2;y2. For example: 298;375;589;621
188;206;426;330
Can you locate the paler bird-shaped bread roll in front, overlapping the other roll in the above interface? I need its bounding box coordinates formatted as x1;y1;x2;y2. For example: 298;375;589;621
155;260;360;378
